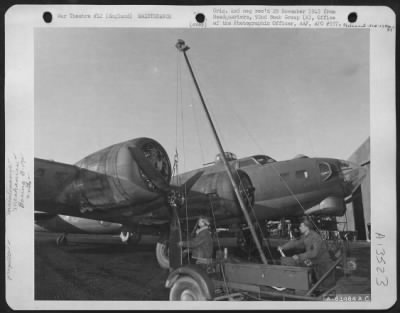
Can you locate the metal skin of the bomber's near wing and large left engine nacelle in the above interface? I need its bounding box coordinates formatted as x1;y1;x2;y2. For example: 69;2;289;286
35;138;171;217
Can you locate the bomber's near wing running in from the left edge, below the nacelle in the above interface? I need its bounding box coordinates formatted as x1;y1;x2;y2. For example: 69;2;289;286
34;158;172;224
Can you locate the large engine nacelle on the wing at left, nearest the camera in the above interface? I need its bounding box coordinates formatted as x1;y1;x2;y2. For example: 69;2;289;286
73;138;171;211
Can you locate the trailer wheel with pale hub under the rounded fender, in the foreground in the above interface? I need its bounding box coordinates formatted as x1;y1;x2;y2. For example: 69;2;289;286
169;276;206;301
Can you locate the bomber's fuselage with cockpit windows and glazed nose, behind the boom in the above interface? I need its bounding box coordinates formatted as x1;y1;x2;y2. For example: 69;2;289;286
173;156;362;224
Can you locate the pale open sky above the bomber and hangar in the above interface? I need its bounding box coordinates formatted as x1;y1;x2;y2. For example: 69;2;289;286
35;28;370;171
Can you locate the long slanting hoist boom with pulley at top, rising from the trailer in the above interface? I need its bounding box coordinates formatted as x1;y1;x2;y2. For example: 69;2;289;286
175;39;268;264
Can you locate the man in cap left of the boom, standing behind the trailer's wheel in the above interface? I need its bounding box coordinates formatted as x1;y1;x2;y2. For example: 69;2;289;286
178;217;213;264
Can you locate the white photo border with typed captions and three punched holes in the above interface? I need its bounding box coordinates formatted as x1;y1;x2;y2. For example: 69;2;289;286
5;5;397;310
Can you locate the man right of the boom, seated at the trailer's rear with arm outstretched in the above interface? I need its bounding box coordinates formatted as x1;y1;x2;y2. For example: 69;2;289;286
278;218;335;289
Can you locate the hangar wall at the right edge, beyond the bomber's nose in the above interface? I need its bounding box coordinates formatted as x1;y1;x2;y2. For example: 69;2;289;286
338;137;371;240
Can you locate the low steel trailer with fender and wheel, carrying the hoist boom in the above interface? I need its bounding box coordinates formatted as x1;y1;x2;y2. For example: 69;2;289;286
165;258;343;301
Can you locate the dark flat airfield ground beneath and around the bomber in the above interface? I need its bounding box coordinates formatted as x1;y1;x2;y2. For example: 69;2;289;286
35;233;370;300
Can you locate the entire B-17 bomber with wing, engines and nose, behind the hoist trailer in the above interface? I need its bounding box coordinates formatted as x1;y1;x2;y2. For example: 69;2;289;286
35;39;365;268
